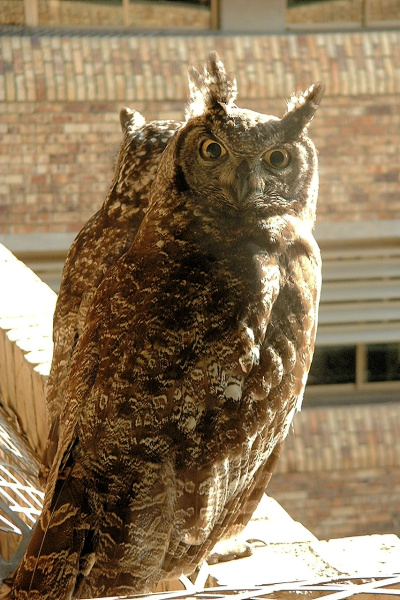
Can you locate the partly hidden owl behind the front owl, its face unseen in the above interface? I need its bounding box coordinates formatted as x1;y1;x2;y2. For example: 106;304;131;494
40;108;180;483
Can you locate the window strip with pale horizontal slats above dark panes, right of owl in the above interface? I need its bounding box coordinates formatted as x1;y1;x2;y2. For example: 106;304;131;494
305;239;400;404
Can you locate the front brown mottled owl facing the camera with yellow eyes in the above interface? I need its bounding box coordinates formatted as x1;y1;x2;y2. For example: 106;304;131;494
12;53;323;600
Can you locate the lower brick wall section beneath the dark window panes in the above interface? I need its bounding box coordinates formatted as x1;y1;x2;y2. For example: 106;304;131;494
268;404;400;539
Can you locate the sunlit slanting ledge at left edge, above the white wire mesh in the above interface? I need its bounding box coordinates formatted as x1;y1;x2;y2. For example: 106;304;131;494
0;245;57;455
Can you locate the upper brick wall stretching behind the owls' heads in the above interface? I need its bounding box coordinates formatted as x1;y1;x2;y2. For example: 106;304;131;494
0;31;400;233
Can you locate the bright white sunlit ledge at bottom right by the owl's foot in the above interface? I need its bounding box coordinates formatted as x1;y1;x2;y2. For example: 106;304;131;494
209;496;400;589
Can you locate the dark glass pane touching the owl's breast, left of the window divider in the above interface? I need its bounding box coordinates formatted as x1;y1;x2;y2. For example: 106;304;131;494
308;346;356;385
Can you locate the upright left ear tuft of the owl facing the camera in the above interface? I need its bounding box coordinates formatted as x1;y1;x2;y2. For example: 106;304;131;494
186;52;237;118
